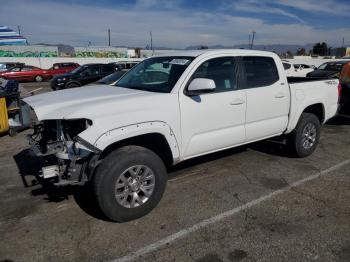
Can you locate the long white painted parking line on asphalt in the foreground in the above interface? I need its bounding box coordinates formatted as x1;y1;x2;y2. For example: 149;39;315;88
112;159;350;262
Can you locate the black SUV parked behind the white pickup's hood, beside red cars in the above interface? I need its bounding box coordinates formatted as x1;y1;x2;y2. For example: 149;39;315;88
50;64;116;90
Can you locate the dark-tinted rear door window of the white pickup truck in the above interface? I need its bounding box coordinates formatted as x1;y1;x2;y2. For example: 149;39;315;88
242;56;279;88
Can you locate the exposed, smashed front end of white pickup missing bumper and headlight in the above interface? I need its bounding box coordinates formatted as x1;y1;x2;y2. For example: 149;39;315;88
28;119;101;185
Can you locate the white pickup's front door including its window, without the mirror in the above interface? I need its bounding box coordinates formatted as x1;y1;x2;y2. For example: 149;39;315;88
180;57;246;159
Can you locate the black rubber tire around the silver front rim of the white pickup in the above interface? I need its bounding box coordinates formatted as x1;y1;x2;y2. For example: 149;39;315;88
93;146;167;222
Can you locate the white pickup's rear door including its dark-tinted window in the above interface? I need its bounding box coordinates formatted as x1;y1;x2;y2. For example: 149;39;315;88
240;56;290;141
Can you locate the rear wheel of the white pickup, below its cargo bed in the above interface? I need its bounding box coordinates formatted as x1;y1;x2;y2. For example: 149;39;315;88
287;113;321;157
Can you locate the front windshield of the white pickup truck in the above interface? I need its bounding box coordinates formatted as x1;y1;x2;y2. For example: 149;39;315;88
116;56;194;93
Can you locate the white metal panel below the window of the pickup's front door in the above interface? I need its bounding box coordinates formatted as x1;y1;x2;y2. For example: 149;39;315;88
180;90;246;158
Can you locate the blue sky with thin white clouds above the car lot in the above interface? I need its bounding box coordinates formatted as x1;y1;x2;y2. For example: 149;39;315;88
0;0;350;48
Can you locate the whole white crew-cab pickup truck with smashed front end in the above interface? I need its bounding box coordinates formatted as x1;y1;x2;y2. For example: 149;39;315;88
24;50;338;222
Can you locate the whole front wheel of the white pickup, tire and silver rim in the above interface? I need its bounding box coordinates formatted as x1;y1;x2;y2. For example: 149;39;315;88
93;146;167;222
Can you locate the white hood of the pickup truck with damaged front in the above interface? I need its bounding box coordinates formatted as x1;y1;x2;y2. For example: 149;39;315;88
23;85;169;121
